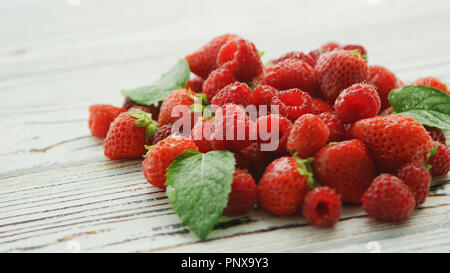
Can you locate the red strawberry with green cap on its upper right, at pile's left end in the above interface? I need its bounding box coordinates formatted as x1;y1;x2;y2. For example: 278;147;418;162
103;110;156;160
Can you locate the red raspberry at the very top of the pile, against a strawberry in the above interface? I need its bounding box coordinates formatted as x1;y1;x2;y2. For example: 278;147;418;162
217;38;263;82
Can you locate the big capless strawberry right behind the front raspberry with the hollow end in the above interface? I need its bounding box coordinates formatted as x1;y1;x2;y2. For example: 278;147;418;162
312;139;376;204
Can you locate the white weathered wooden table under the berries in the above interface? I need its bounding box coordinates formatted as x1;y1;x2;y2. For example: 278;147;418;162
0;0;450;252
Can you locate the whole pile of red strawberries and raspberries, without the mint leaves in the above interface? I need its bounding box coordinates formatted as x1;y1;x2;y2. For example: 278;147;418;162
89;34;450;230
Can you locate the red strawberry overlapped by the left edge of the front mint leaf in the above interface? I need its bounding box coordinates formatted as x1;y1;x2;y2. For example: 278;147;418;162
142;136;198;189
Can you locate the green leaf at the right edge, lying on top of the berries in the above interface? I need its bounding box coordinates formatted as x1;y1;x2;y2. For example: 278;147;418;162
388;85;450;130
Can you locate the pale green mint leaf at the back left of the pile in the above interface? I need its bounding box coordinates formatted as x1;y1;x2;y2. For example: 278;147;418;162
122;59;190;106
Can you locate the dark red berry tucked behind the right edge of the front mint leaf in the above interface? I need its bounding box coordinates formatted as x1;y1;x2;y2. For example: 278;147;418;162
223;169;257;215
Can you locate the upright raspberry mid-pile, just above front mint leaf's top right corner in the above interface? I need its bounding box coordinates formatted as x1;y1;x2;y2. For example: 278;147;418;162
214;103;252;152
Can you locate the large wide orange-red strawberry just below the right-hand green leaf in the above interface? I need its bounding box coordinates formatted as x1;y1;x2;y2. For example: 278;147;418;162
352;115;433;172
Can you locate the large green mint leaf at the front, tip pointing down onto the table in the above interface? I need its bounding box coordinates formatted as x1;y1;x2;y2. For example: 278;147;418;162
166;150;235;240
